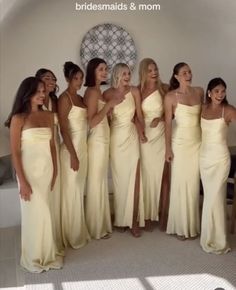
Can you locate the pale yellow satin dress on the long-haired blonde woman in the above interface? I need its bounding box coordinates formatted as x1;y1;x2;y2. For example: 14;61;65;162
141;90;165;221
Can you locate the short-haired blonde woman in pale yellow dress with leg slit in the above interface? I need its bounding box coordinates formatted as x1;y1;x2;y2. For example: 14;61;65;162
104;63;144;237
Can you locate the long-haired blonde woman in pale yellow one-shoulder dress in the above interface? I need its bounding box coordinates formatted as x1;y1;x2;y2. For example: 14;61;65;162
139;58;168;231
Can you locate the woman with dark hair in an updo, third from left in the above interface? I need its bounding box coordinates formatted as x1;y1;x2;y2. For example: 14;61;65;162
58;62;90;249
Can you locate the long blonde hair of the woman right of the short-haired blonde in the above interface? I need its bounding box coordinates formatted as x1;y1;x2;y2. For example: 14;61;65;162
139;58;165;97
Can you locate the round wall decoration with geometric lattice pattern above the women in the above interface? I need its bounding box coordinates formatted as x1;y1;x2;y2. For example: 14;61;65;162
80;23;137;70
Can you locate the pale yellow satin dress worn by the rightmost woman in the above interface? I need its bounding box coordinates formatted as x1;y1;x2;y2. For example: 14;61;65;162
200;113;230;254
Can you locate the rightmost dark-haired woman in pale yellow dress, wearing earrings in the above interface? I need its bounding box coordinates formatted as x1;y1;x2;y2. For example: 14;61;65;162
200;78;236;254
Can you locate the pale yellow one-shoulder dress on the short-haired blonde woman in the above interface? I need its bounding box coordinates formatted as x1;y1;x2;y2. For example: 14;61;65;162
110;92;144;228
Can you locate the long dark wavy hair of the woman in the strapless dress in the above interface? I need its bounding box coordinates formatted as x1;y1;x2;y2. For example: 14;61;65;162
5;77;45;127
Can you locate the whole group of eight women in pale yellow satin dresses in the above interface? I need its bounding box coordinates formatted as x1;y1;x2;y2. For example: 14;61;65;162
6;58;236;272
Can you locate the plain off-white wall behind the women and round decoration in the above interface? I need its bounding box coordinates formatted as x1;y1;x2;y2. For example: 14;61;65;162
0;0;236;145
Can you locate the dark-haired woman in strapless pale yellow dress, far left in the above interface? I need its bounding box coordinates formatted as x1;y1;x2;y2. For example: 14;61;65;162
6;77;62;273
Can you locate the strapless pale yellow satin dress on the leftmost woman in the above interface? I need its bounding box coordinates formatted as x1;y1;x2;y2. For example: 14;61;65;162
21;128;63;273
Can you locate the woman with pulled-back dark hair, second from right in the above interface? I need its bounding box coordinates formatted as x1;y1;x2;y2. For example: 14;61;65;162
164;62;203;240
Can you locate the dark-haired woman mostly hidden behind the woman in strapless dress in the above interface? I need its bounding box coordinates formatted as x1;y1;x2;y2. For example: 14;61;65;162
35;68;64;254
